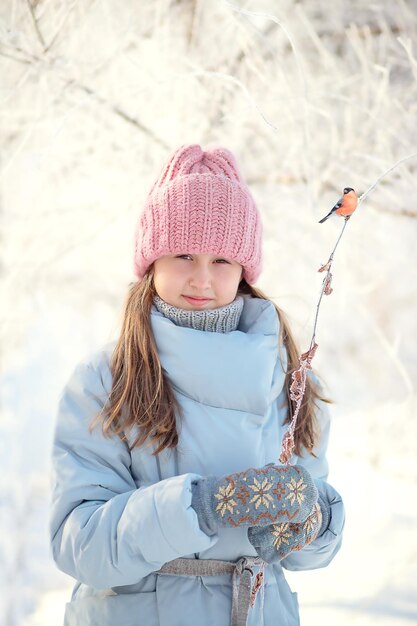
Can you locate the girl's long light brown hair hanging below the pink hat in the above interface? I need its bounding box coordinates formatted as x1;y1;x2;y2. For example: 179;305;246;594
91;269;326;455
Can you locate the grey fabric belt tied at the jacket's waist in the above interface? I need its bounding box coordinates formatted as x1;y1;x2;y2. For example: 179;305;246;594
155;556;265;626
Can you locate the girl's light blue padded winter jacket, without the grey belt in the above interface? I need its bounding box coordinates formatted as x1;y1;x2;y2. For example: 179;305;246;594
51;297;344;626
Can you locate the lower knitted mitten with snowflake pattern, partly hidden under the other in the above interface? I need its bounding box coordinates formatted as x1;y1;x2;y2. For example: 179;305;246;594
248;504;322;563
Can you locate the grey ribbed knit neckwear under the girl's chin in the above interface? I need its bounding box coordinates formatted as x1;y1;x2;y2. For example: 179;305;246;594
153;296;244;333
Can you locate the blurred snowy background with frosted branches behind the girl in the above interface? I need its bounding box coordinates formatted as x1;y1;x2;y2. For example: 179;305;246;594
0;0;417;626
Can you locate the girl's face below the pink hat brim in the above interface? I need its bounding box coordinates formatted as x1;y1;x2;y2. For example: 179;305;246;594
153;254;243;311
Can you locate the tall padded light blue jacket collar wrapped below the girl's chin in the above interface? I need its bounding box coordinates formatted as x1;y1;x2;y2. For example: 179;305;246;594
151;296;286;415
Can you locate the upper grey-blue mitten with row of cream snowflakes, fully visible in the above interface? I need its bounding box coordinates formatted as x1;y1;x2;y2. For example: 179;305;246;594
191;463;318;535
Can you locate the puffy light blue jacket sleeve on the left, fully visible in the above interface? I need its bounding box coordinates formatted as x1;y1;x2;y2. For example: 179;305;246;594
50;356;217;589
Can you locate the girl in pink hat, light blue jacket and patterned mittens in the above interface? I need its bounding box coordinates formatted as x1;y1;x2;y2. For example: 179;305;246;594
51;145;344;626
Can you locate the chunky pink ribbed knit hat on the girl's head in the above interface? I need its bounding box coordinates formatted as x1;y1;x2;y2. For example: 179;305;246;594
134;144;262;283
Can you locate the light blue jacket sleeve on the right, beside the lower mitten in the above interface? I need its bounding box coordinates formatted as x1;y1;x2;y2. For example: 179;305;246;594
281;386;345;571
